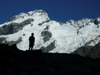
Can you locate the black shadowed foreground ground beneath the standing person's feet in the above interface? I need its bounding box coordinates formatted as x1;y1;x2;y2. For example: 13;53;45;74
0;44;100;75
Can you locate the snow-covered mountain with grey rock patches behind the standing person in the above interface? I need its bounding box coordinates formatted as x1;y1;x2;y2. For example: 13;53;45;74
0;10;100;53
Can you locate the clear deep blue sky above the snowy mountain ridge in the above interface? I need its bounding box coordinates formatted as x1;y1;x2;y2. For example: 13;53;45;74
0;0;100;24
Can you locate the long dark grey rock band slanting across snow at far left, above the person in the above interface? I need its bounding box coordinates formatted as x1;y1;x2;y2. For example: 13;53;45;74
0;19;34;35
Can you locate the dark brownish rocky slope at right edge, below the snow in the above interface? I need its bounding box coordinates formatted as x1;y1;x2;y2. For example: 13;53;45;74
72;43;100;59
